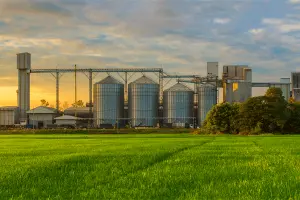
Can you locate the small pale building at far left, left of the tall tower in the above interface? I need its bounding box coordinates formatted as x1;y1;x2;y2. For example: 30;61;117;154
0;106;19;126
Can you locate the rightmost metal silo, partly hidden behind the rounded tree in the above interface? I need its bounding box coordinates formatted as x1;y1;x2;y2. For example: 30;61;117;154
197;84;217;126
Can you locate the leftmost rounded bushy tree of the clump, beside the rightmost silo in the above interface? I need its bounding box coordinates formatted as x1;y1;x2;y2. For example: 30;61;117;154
203;103;240;133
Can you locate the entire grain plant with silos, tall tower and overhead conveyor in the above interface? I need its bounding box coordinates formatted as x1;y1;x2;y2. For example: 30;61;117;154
0;53;294;128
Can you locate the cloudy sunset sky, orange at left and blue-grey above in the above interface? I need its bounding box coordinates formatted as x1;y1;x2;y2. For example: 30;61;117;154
0;0;300;106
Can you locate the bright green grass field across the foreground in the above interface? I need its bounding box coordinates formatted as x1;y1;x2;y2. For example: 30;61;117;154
0;134;300;200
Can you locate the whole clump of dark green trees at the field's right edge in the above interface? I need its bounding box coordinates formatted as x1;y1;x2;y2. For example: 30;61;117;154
199;88;300;135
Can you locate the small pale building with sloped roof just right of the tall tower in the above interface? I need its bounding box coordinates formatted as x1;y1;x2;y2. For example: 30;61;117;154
27;106;59;128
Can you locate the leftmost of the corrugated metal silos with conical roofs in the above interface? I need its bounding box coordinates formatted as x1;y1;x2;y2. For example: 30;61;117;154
94;76;124;127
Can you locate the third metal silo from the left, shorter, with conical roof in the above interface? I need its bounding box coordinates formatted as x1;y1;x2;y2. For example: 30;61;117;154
164;83;194;127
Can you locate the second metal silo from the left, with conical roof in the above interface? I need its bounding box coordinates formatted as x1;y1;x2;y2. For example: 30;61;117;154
128;76;159;127
